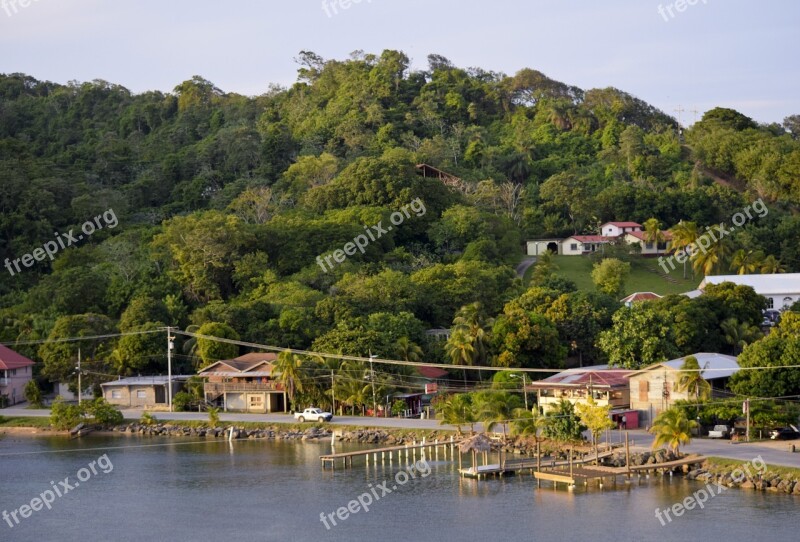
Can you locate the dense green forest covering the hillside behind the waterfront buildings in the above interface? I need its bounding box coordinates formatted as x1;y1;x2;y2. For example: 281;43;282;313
0;50;800;396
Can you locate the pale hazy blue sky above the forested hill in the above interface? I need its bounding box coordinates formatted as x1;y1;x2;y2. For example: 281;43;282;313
0;0;800;125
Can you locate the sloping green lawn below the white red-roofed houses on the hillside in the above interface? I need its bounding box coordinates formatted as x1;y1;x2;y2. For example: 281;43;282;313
525;256;703;295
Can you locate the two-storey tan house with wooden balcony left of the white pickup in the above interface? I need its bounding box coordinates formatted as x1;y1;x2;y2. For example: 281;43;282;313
198;352;287;413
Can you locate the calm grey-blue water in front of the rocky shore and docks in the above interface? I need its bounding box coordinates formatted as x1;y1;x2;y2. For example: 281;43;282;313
0;436;800;542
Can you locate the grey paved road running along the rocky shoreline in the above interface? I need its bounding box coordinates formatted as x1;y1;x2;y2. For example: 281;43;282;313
6;408;800;468
